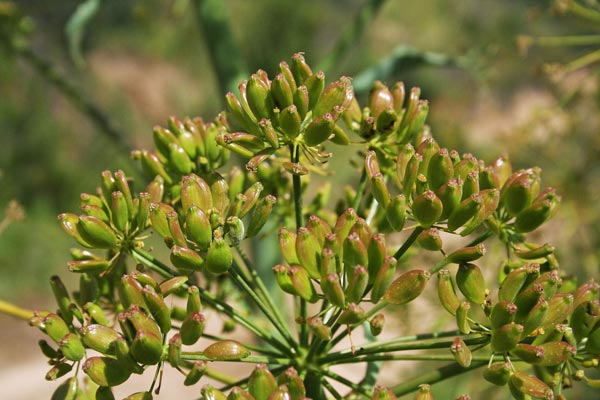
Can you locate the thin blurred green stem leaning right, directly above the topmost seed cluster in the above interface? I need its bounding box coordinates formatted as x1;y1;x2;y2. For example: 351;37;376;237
318;0;386;72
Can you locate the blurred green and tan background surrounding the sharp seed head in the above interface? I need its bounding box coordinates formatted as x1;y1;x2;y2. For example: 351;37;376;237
0;0;600;399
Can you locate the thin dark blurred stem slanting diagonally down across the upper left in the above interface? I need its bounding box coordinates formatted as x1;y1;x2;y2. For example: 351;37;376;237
5;40;132;154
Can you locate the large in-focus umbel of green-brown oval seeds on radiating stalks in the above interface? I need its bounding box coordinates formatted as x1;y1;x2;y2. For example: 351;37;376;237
5;53;600;400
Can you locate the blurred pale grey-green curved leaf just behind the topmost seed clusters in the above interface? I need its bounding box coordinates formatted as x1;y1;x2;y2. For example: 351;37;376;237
352;45;459;95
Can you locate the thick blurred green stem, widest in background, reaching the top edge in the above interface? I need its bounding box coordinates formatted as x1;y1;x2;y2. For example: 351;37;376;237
192;0;248;93
